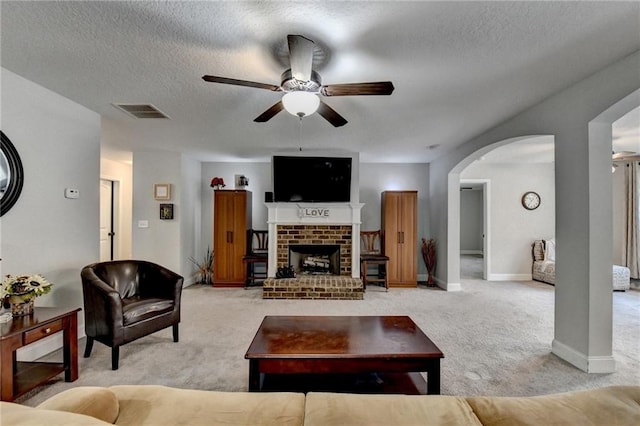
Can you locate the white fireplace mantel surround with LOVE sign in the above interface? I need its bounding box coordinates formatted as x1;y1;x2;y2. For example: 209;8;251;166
265;203;364;278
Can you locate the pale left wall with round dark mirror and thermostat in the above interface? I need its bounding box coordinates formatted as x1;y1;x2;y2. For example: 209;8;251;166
0;68;100;359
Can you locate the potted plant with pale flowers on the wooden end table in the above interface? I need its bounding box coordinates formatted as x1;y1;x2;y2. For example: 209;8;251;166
0;274;53;317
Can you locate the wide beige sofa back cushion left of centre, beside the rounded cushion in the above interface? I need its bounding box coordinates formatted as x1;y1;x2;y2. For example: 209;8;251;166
109;385;304;426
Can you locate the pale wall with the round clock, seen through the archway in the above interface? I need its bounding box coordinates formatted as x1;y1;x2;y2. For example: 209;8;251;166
460;161;556;280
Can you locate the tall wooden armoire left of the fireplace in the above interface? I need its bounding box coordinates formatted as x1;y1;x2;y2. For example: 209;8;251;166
213;190;251;287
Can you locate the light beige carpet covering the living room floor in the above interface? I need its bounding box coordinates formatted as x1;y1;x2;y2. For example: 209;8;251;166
18;280;640;405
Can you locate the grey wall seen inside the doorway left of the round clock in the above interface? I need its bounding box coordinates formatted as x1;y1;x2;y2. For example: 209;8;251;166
460;190;484;254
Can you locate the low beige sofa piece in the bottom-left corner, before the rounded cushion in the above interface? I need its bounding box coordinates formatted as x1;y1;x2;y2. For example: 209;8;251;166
0;402;110;426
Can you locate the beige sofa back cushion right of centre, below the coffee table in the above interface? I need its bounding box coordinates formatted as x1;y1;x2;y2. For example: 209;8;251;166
304;392;481;426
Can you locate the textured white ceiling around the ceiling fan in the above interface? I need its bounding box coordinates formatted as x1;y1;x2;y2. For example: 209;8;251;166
0;1;640;162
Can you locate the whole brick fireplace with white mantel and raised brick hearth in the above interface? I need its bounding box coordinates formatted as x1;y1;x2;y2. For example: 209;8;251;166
263;203;363;299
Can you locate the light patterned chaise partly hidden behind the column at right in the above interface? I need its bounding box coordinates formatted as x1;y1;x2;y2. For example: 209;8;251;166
531;239;631;291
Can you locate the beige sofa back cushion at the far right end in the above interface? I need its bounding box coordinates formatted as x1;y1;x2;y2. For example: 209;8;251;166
467;386;640;426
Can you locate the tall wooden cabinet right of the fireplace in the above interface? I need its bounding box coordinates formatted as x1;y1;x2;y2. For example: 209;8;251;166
381;191;418;287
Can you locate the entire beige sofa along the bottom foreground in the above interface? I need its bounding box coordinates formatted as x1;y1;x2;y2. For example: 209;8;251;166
0;385;640;426
